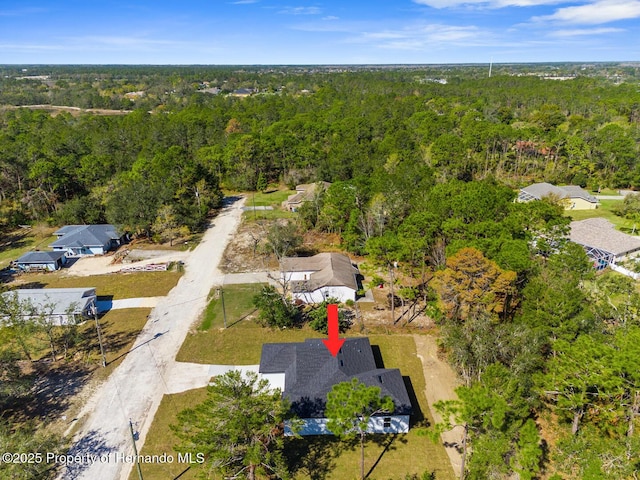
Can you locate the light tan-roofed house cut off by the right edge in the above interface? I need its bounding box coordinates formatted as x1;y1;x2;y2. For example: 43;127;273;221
569;218;640;270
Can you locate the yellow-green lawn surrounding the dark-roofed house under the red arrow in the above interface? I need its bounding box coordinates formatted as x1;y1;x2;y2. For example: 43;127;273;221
141;285;454;480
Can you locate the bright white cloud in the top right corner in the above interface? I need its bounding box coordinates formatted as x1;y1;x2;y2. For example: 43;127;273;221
532;0;640;25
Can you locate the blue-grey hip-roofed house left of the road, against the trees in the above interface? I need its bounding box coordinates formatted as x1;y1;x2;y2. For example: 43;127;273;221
49;225;125;257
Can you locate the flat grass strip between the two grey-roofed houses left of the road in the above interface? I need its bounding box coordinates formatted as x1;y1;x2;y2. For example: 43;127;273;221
11;272;183;300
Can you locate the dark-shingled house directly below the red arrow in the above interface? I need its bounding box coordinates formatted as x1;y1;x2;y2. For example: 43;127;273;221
259;337;411;435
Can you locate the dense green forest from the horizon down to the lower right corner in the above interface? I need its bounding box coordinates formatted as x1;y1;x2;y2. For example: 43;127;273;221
0;65;640;479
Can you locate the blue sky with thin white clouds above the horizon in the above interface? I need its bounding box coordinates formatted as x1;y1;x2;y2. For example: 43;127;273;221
0;0;640;65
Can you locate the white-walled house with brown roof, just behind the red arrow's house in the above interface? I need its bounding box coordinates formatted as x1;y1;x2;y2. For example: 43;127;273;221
281;253;360;303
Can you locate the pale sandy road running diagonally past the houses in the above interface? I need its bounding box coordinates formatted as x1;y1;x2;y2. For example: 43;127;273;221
61;196;244;480
